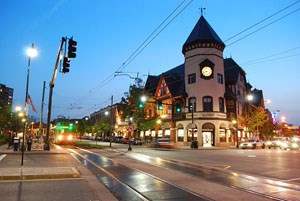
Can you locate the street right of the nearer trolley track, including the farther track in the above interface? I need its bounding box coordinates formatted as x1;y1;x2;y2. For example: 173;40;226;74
72;142;300;200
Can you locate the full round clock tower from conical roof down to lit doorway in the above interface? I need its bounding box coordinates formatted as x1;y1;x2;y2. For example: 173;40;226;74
182;16;228;147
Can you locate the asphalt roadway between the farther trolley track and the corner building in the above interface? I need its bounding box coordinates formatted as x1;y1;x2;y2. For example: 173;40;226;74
82;141;300;183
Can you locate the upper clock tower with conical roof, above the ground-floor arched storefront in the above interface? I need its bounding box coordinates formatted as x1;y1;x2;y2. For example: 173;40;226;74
182;16;225;112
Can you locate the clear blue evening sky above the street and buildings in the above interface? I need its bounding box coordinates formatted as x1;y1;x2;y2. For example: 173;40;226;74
0;0;300;125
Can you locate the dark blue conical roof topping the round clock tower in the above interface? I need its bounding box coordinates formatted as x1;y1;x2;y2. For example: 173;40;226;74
182;16;225;53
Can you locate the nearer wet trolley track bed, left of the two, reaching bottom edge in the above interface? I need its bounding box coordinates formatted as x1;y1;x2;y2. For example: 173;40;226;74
69;149;212;201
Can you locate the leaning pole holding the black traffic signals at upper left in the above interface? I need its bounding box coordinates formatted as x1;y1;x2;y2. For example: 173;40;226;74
44;37;66;151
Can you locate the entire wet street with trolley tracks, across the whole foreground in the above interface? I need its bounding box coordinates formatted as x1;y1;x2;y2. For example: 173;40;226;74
0;141;300;201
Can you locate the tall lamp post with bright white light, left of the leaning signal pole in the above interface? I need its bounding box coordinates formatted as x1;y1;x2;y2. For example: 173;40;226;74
21;43;38;166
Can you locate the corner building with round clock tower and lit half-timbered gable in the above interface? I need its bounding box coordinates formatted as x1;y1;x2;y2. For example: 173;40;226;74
145;16;258;147
